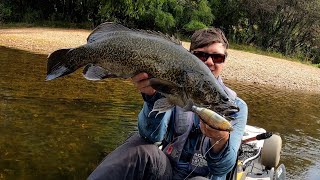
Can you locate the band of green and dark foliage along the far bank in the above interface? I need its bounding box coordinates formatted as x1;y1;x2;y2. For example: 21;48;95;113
0;0;320;64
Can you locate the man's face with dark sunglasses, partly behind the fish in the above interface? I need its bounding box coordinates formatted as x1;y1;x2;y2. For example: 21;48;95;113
192;43;226;77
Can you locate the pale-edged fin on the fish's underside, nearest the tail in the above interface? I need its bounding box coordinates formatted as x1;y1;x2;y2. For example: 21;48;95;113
82;64;118;81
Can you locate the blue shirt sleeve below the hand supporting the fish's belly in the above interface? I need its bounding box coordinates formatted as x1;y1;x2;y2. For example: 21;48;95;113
138;93;172;143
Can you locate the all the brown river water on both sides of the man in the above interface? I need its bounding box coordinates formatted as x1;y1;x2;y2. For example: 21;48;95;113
0;47;320;180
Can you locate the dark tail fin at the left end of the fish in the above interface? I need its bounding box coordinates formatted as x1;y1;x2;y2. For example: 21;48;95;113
46;49;75;81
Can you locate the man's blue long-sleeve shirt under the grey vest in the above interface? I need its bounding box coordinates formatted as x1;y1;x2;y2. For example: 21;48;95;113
138;90;248;179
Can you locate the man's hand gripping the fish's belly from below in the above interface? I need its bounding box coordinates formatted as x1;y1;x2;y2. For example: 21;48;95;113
131;73;156;96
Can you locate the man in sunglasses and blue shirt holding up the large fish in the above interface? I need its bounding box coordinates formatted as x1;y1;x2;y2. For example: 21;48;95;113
88;28;248;180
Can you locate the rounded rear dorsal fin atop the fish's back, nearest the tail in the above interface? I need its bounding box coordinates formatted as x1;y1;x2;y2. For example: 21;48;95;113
87;22;132;43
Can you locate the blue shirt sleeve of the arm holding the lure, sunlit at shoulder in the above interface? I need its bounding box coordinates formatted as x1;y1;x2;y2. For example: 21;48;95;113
202;97;248;179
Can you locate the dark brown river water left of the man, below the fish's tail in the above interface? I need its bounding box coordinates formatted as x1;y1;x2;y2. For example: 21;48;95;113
0;48;142;179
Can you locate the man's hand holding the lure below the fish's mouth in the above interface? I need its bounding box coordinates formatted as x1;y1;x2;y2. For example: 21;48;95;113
200;120;229;153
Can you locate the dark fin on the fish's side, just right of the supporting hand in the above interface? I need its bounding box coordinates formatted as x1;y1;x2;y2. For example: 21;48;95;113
150;78;182;94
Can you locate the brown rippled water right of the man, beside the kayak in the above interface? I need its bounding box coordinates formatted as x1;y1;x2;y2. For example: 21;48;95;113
227;78;320;179
